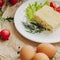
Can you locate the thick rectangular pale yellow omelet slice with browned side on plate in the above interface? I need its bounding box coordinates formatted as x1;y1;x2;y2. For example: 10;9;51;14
34;5;60;31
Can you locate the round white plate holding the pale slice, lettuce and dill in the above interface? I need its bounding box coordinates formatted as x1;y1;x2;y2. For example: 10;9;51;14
14;0;60;43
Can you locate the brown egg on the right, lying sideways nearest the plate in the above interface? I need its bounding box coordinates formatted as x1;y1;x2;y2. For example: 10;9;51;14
37;43;57;58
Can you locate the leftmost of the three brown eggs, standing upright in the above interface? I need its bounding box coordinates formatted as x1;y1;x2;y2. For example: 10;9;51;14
20;45;35;60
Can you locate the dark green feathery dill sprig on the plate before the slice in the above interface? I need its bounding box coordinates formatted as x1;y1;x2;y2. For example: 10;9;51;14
23;22;45;33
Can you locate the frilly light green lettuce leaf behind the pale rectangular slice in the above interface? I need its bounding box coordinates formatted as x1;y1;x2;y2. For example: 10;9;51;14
26;1;49;22
